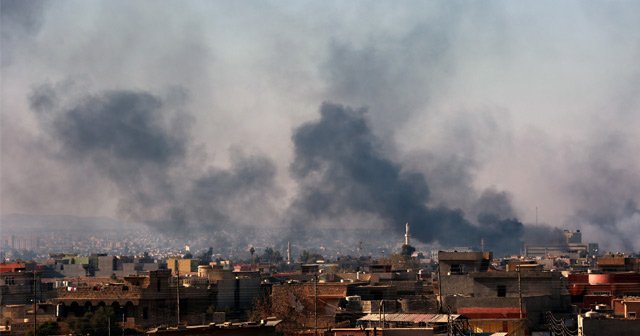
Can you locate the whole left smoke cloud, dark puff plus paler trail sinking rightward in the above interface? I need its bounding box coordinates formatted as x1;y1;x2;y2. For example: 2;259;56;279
30;85;277;236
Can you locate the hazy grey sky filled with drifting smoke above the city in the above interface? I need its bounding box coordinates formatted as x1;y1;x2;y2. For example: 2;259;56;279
0;0;640;251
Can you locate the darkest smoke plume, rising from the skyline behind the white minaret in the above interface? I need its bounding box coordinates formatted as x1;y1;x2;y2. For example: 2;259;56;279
291;103;522;252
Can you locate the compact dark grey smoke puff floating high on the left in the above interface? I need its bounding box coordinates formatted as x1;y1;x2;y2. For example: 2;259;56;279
31;88;187;166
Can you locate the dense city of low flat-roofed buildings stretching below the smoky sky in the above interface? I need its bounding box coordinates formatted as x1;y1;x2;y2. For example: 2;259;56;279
0;217;640;336
